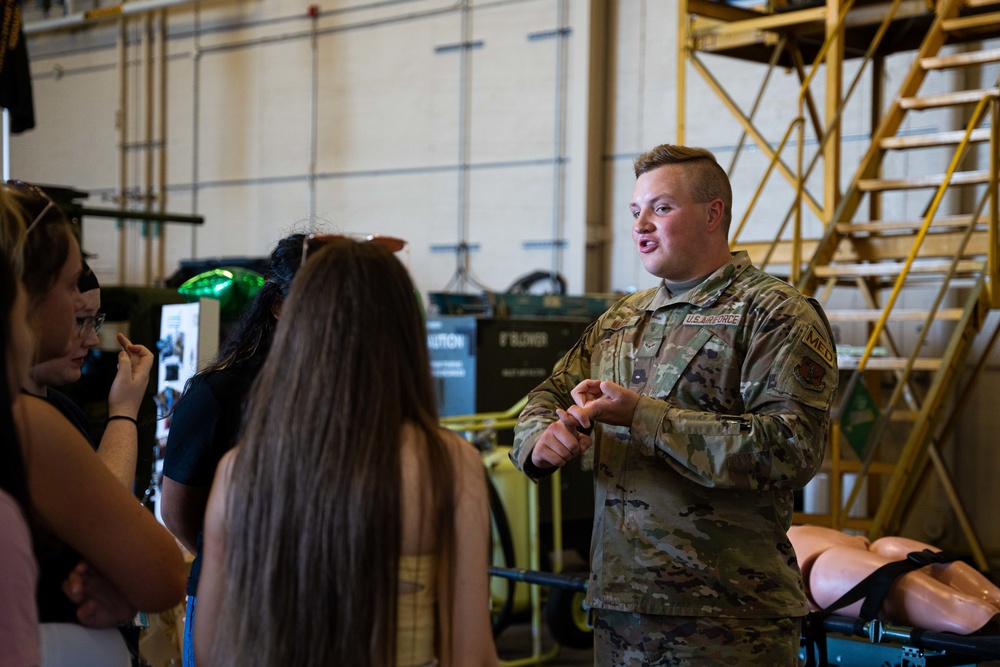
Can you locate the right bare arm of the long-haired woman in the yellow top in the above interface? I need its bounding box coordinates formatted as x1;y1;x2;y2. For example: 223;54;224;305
440;435;498;667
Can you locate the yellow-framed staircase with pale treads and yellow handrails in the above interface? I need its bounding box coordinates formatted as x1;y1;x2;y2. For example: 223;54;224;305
800;0;1000;565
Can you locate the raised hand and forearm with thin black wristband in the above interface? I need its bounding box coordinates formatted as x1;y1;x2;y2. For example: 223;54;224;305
97;334;153;491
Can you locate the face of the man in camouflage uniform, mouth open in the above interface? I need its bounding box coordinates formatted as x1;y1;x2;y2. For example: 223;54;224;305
629;164;721;282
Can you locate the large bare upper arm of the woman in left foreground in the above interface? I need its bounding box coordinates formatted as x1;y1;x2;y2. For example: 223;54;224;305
14;396;184;611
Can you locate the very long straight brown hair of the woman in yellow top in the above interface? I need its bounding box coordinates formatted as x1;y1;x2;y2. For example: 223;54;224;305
213;240;455;667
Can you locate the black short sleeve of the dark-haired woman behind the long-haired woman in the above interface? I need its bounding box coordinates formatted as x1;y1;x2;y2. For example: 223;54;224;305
163;379;225;487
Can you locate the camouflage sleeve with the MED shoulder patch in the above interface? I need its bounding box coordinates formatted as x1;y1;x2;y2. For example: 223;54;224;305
631;298;838;490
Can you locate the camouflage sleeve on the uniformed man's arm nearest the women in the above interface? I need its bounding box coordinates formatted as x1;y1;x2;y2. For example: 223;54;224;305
510;323;596;480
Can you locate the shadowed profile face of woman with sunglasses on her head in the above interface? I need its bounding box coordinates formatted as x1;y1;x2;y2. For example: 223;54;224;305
32;239;83;363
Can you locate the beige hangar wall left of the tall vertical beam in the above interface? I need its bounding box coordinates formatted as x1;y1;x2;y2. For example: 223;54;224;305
11;0;604;292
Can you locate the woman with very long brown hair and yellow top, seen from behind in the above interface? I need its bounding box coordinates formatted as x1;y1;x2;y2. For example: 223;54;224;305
194;239;497;667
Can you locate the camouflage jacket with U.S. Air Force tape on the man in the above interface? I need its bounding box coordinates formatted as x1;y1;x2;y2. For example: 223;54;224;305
511;252;838;618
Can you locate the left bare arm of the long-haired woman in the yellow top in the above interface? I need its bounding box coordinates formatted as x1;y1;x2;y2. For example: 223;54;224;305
194;449;238;665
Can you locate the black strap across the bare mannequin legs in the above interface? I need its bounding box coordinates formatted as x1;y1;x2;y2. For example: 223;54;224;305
802;549;960;667
